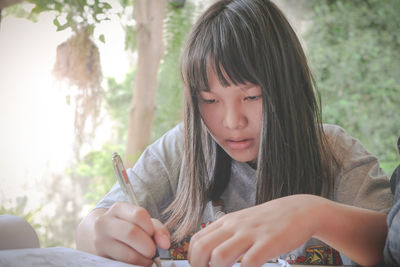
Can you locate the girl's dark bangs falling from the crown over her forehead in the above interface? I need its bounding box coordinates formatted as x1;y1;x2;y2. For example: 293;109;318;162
181;1;258;96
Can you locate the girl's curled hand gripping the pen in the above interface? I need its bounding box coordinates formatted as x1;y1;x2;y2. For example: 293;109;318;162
94;202;170;266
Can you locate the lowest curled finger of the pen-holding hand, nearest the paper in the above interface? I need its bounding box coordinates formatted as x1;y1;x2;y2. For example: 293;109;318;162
97;240;153;266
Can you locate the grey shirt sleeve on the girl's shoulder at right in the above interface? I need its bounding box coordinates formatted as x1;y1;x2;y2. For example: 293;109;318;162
324;125;393;213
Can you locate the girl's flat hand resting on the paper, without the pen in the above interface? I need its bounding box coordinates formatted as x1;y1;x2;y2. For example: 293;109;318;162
188;195;330;266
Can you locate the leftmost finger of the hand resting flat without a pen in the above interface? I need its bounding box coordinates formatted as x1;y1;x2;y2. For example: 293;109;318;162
188;228;233;266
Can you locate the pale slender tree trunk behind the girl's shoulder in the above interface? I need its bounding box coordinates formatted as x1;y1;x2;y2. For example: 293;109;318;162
124;0;167;167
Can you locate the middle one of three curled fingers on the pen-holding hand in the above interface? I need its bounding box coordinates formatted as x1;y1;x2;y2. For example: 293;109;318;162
102;213;156;258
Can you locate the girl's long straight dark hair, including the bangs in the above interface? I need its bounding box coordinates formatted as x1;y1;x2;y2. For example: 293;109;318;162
162;0;338;241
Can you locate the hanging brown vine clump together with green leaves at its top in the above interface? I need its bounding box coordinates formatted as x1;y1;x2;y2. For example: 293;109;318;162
28;0;111;160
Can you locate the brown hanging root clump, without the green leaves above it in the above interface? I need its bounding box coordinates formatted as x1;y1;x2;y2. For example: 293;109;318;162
53;28;102;158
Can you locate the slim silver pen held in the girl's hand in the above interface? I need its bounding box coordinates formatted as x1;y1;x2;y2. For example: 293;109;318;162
112;152;161;267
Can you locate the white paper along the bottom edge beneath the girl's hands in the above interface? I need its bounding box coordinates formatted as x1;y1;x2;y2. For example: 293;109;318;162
0;247;354;267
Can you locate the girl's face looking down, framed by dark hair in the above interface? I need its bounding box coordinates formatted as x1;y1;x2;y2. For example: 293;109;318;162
199;73;262;164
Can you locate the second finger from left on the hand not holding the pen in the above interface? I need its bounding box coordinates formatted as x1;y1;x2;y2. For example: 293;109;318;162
210;235;253;266
